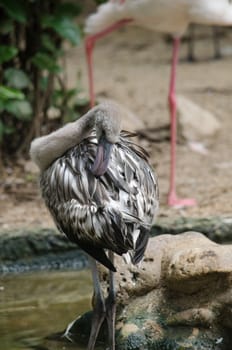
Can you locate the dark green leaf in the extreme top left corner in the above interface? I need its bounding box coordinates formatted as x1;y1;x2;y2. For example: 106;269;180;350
0;0;27;23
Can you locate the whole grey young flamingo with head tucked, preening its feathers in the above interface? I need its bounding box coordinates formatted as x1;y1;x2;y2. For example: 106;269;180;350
30;103;158;350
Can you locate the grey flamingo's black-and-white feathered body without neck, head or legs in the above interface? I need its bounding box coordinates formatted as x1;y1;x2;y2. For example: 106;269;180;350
40;133;158;271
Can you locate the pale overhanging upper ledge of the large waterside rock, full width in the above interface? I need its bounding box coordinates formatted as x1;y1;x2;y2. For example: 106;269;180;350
111;232;232;298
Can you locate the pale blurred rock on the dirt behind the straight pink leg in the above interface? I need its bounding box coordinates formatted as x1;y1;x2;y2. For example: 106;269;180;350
177;96;221;142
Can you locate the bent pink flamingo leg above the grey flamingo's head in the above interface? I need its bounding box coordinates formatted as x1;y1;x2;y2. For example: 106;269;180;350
85;18;132;108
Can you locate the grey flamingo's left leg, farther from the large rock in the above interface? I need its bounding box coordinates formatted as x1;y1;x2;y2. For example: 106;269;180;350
87;258;106;350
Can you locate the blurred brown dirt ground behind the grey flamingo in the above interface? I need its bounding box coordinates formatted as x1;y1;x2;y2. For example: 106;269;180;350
0;22;232;230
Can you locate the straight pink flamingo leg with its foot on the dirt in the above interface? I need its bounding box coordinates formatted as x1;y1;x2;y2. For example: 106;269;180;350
168;38;196;207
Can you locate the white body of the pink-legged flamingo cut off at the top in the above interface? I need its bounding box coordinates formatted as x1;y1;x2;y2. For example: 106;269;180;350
85;0;232;36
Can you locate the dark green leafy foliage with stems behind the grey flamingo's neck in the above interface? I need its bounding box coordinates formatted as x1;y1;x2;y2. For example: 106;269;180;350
0;0;87;162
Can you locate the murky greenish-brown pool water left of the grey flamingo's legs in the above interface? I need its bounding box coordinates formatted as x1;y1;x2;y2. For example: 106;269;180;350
0;270;99;350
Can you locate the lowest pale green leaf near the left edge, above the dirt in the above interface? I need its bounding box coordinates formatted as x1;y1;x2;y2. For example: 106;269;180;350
5;100;32;121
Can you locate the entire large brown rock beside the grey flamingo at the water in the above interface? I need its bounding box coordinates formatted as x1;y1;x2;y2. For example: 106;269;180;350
68;232;232;350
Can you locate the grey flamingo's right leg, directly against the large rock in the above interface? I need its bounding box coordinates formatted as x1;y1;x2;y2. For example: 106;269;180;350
106;251;116;350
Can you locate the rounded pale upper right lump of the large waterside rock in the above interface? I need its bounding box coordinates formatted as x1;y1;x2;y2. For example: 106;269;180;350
166;232;232;293
